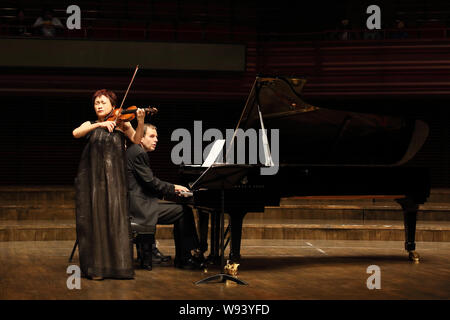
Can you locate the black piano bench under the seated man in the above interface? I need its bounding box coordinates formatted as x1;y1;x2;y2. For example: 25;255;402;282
131;222;156;270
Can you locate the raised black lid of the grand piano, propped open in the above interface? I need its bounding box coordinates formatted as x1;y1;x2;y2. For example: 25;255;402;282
227;77;429;166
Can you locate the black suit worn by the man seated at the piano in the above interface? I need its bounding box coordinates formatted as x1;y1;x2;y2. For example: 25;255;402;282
127;144;198;259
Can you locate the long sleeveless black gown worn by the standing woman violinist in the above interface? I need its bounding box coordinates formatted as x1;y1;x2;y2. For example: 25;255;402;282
75;128;134;279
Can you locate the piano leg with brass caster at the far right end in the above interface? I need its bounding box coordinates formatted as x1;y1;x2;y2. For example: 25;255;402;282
396;197;420;263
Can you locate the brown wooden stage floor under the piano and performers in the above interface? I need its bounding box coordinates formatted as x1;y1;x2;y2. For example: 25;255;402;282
0;240;450;300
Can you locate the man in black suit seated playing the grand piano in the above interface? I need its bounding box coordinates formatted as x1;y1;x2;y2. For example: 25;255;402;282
127;124;201;269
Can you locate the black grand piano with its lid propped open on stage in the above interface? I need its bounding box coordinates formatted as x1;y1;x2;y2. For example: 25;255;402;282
180;76;430;262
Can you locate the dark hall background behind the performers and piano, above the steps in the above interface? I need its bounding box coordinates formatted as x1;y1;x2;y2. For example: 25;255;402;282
0;0;450;187
